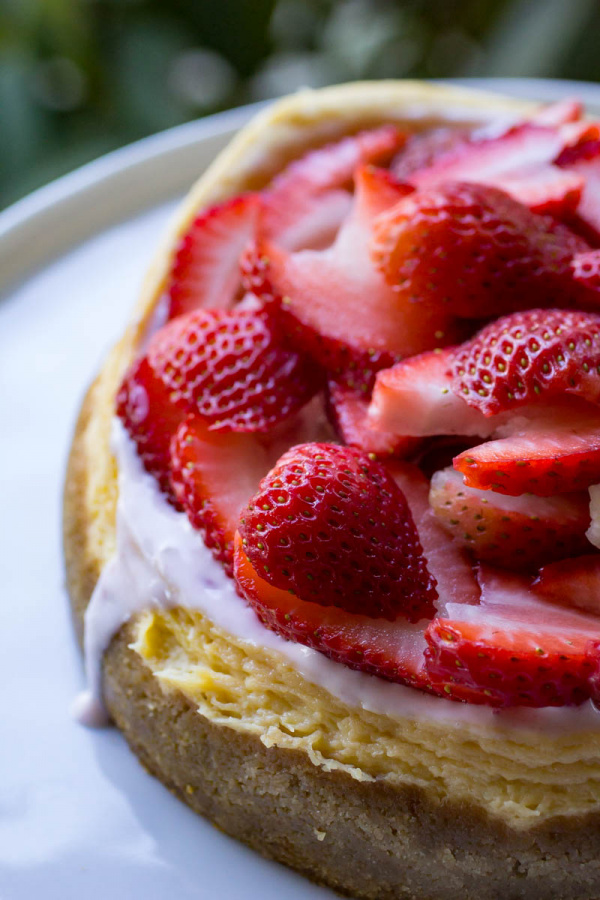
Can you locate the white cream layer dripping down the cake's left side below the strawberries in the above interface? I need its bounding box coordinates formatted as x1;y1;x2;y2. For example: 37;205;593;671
74;419;600;733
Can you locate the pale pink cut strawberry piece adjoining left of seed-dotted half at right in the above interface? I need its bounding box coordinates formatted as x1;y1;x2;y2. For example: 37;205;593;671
369;348;504;437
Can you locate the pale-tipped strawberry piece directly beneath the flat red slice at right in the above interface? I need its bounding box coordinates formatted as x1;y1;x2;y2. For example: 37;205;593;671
429;468;590;571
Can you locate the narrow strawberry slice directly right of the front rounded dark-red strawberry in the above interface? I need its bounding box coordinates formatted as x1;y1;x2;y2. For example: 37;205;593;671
386;460;481;612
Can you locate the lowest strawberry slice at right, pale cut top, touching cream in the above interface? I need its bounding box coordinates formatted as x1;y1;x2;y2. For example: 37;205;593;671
426;574;600;707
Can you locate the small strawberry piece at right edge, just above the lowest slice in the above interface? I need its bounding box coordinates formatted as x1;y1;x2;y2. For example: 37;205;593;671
532;544;600;615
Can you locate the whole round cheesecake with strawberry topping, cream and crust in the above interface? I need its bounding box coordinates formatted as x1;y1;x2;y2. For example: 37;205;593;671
64;82;600;900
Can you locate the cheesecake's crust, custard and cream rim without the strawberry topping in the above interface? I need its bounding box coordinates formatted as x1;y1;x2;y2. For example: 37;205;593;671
64;82;600;900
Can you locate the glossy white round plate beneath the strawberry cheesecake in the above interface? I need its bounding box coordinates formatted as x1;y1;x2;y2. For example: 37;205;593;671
0;79;600;900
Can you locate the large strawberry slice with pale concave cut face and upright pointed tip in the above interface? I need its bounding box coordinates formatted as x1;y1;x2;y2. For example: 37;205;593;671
243;168;458;391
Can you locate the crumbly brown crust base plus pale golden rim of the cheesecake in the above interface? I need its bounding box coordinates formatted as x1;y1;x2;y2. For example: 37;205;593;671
64;82;600;900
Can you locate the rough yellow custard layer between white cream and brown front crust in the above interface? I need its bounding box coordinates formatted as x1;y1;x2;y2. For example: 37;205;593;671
132;609;600;827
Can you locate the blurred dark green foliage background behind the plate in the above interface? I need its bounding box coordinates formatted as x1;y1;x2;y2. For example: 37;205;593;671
0;0;600;206
